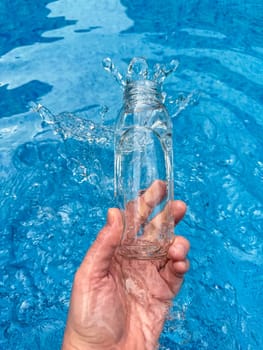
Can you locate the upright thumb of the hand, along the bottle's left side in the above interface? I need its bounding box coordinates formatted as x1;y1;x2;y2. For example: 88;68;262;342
80;208;123;278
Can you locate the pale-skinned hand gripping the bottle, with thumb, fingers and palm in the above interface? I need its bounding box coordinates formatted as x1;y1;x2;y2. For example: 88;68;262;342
62;181;189;350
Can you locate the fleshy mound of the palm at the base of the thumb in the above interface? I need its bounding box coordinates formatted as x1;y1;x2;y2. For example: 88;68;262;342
69;258;126;349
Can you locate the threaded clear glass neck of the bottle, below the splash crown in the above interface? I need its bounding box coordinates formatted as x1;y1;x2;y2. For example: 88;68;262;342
124;80;163;112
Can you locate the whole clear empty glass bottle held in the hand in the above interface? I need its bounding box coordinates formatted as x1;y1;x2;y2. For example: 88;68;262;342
115;80;173;259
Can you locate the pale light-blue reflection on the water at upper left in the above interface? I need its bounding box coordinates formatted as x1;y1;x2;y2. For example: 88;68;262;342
0;0;134;117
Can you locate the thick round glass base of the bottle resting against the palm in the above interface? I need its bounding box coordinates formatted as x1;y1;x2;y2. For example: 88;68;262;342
118;241;169;260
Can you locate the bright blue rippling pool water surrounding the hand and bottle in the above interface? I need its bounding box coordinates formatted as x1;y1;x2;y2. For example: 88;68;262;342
0;0;263;350
